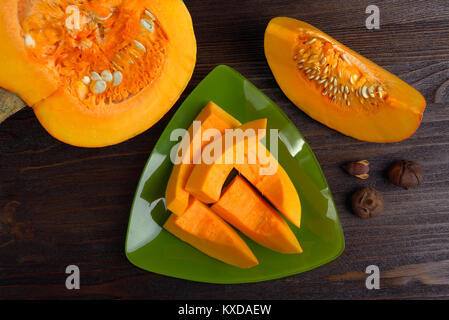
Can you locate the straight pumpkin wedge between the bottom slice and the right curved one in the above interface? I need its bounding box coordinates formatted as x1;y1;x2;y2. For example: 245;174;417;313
211;176;302;253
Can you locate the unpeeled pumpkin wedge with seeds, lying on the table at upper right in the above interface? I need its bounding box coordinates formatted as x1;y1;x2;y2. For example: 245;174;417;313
265;17;426;142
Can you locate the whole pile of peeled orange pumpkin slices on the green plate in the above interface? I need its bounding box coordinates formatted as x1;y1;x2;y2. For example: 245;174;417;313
164;102;302;268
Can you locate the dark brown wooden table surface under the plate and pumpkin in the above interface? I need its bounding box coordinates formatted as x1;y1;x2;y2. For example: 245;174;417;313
0;0;449;299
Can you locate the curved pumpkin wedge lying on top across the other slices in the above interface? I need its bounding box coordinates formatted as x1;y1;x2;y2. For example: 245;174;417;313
185;119;267;203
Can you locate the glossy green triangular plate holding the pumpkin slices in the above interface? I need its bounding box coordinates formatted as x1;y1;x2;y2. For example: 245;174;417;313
125;66;344;283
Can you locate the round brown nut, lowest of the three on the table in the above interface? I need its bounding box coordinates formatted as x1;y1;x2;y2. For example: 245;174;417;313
351;187;384;219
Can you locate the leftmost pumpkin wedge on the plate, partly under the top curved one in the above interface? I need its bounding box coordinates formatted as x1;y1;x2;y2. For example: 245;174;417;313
165;102;241;215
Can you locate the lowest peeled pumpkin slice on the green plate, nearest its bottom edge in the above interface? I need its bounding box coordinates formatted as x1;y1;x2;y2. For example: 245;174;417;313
164;198;259;268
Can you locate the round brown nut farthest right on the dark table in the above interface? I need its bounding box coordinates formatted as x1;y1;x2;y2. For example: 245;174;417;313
388;160;424;189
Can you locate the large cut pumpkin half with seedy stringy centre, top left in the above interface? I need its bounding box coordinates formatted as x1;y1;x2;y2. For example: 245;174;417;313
0;0;196;147
